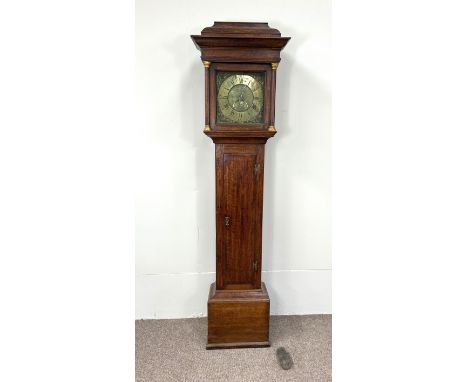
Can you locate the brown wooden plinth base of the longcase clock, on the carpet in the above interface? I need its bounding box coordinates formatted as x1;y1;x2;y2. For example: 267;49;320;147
206;283;270;349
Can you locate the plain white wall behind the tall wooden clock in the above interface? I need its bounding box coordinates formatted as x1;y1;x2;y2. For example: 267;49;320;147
135;0;331;318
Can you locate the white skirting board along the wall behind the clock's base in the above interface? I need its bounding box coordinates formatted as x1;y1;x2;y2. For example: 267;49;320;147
135;269;332;319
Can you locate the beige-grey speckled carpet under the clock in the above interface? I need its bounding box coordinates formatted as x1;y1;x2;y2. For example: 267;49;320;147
135;315;332;382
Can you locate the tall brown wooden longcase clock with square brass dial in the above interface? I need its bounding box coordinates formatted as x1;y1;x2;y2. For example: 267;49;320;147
191;22;290;349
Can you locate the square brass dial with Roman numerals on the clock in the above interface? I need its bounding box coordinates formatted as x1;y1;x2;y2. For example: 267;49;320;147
216;72;265;124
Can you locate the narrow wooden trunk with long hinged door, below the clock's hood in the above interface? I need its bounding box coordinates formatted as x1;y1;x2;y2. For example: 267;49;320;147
216;143;264;289
